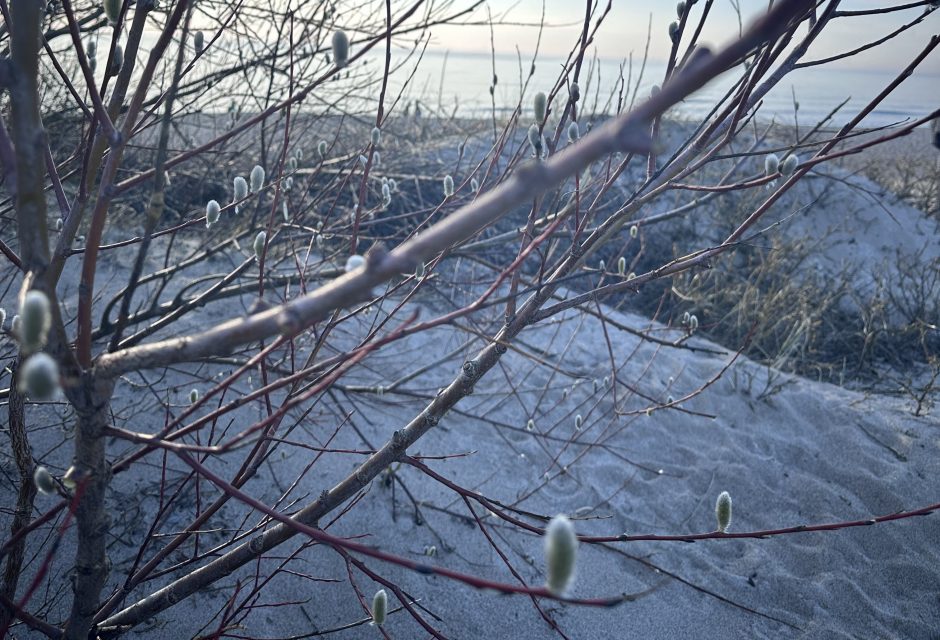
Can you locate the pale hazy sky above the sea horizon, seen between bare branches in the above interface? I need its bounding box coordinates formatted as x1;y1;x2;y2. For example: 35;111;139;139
432;0;940;74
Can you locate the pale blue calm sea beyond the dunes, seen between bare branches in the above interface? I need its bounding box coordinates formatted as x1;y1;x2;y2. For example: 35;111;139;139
386;51;940;127
